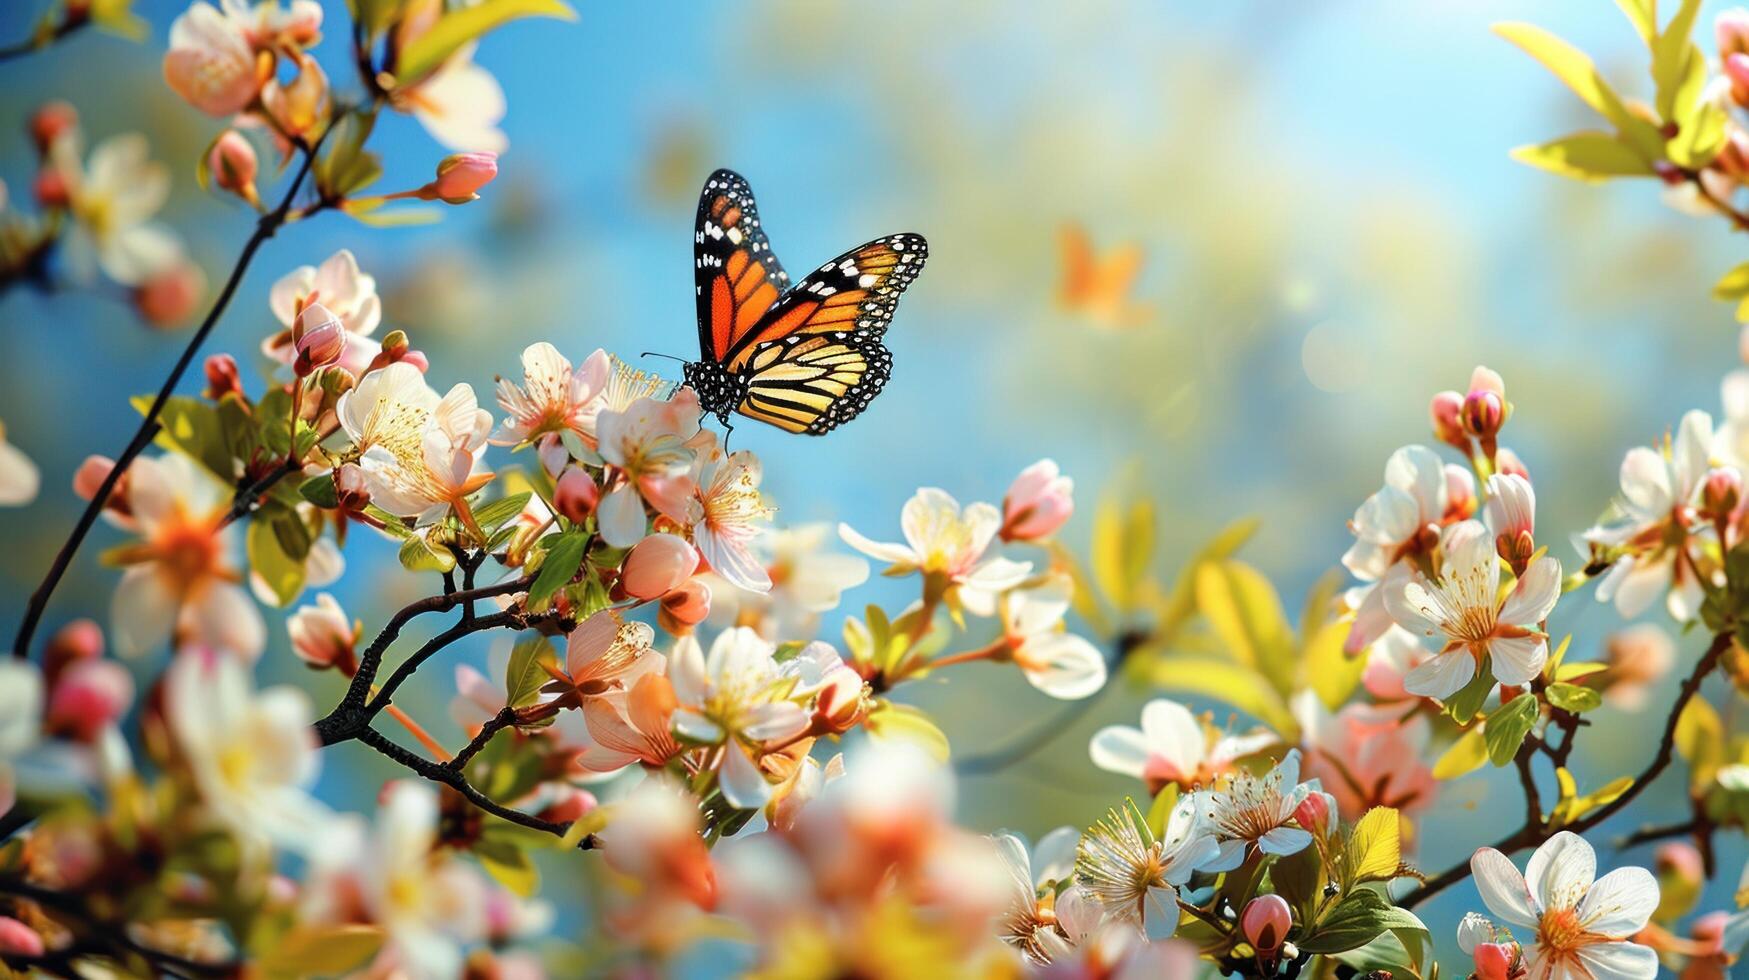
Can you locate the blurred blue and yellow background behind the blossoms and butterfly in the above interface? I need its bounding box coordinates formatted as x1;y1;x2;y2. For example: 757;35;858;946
0;0;1744;971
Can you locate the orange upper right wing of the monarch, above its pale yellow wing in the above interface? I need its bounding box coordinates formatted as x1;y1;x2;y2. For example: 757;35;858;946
722;235;929;373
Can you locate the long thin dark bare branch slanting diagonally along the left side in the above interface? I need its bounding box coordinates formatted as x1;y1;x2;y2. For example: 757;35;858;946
12;140;332;658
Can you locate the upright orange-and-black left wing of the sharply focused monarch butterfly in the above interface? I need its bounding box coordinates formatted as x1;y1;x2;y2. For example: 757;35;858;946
693;170;789;362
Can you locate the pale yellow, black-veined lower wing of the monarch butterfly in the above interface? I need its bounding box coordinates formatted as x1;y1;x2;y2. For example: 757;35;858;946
735;331;892;436
